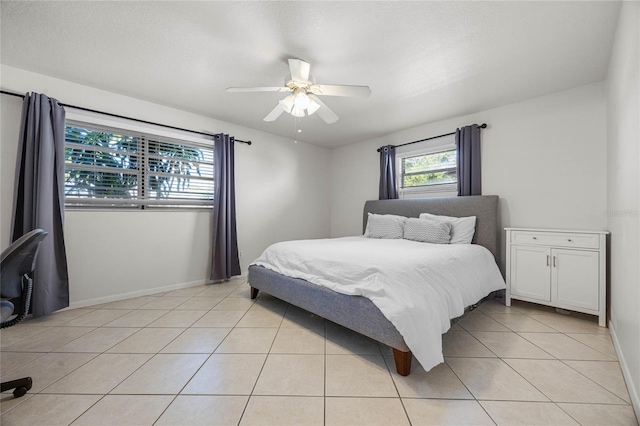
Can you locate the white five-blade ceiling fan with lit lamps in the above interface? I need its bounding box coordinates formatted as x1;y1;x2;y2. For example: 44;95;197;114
227;59;371;124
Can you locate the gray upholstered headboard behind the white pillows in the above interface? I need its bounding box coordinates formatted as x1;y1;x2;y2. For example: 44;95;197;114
362;195;500;259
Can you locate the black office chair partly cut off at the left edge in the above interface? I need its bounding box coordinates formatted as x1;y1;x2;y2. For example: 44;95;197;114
0;229;47;398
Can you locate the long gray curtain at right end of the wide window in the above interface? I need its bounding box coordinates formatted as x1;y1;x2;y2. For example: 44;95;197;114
211;133;241;281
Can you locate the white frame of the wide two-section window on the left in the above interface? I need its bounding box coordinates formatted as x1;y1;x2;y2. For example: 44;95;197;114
65;111;215;211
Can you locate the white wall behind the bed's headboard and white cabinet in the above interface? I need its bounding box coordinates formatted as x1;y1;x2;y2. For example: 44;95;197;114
331;83;606;270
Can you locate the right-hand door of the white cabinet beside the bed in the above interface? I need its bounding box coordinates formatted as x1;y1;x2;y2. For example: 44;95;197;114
551;249;600;310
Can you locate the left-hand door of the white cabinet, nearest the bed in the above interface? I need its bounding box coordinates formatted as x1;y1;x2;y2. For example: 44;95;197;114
510;246;551;302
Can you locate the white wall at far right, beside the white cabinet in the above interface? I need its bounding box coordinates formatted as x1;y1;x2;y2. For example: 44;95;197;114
607;2;640;418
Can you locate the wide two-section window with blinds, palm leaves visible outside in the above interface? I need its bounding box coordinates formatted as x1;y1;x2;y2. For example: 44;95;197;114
65;121;213;209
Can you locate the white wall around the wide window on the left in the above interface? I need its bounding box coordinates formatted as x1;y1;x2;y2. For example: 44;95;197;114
0;66;330;306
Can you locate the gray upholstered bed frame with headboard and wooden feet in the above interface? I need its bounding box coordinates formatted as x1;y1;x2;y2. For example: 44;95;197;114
248;195;499;376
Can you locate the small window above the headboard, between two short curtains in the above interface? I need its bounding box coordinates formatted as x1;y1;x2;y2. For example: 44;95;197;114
396;137;458;198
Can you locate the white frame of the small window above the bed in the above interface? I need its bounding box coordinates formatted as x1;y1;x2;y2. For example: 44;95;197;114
396;135;458;198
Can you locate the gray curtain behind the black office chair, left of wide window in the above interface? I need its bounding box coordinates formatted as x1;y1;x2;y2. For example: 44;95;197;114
11;93;69;317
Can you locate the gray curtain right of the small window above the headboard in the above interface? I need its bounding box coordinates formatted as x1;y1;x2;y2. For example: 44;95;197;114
456;124;482;195
